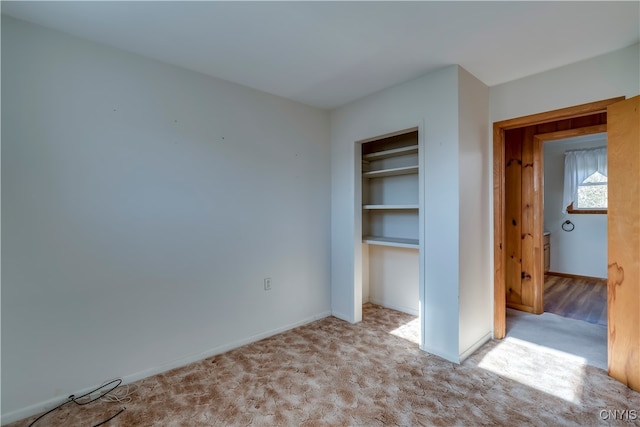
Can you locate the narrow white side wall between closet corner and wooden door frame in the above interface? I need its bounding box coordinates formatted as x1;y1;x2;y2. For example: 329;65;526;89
458;68;493;359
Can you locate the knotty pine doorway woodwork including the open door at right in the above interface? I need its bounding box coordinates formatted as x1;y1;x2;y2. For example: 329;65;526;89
493;96;640;390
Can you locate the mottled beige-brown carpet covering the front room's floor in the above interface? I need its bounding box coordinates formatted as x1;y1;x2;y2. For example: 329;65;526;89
12;304;640;426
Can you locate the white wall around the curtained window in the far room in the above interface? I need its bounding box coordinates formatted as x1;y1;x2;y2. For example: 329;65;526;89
544;135;607;278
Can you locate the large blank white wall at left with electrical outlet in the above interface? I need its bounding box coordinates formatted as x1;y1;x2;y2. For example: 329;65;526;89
2;16;331;423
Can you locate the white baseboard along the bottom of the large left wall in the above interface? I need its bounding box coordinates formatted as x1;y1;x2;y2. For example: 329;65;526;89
0;311;331;425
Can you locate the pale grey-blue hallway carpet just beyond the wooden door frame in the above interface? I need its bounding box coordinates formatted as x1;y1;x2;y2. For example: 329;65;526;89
507;309;607;371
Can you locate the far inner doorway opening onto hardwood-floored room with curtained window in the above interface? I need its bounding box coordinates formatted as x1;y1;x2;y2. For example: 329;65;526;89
537;130;607;328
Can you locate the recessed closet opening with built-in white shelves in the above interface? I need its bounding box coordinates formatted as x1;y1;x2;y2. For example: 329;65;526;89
356;127;422;345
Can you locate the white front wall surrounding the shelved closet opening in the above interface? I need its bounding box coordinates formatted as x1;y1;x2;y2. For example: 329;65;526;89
331;66;491;361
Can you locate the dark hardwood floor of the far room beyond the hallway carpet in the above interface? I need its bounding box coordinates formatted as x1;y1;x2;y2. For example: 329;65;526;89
544;274;607;326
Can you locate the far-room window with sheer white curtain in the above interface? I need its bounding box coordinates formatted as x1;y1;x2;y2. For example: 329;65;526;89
562;147;607;213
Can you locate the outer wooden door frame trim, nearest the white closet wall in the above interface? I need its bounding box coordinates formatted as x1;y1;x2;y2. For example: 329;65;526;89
493;96;625;339
